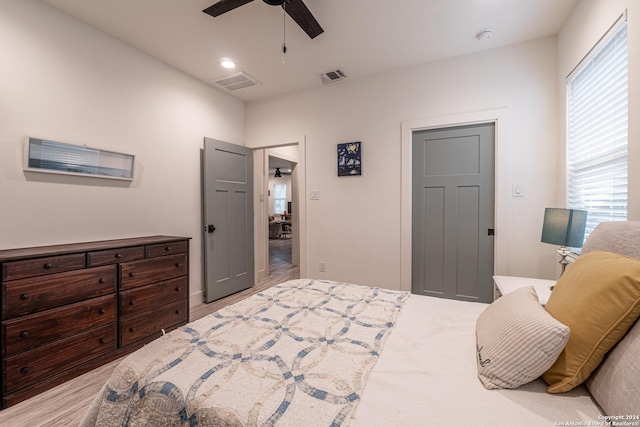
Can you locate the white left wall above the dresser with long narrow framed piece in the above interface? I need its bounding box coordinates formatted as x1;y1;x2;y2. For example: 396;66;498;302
0;0;244;305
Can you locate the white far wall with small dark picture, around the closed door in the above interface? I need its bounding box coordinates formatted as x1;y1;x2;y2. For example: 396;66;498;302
246;38;558;289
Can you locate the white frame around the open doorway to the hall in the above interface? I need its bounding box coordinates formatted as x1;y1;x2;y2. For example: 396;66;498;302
246;135;307;283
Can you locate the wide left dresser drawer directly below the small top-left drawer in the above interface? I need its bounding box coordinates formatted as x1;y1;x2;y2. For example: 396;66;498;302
2;265;117;320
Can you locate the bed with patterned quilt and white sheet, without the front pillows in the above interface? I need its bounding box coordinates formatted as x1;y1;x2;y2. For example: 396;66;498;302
81;222;640;427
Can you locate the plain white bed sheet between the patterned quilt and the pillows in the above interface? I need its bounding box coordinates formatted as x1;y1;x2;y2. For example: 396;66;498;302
350;295;602;427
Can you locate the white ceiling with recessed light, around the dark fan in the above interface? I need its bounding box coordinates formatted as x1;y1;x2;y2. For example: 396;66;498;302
42;0;577;101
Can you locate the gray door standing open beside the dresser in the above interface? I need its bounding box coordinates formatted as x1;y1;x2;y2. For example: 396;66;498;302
203;138;254;302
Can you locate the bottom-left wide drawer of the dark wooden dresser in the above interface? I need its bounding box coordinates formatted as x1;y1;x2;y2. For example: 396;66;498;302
2;324;116;394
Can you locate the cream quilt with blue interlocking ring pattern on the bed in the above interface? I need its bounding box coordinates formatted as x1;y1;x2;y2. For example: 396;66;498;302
81;279;409;427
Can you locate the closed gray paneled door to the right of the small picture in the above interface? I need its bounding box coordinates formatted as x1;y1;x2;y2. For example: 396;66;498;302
411;123;495;302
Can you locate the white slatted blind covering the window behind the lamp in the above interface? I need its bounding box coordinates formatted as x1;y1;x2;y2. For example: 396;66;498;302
567;19;628;239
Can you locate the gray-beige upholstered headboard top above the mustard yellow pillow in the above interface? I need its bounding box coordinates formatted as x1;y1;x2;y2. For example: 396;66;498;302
581;221;640;258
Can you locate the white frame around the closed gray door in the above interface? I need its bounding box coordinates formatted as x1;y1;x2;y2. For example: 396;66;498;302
400;108;509;292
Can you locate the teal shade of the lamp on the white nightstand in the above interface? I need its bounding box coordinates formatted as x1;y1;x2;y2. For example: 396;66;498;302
541;208;587;248
